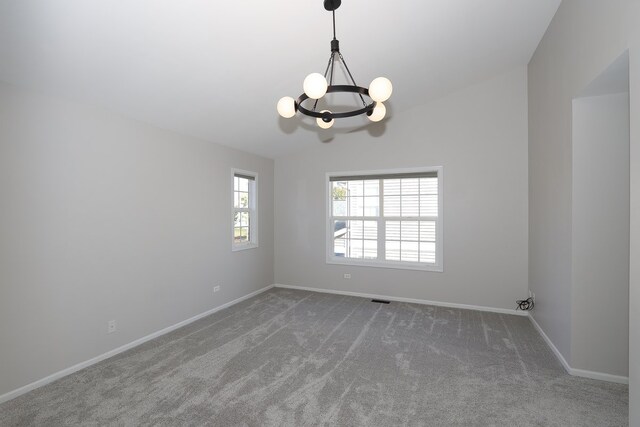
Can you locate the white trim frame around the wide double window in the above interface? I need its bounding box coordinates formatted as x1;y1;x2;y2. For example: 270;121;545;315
325;166;444;273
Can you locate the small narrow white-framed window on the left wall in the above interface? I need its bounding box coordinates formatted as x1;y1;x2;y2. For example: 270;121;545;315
232;169;258;250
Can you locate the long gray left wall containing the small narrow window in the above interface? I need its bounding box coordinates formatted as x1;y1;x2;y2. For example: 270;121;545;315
0;84;274;395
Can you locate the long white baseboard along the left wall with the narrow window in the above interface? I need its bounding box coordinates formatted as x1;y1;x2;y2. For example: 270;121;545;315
0;285;273;403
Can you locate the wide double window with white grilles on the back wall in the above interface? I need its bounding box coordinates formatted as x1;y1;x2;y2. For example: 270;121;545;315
327;167;443;271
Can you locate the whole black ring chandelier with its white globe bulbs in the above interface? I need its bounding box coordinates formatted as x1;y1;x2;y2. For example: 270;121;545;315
277;0;393;129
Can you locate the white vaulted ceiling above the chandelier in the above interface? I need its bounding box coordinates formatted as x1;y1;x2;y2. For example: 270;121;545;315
0;0;560;157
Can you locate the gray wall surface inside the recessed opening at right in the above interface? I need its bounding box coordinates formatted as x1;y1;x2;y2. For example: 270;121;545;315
571;92;629;376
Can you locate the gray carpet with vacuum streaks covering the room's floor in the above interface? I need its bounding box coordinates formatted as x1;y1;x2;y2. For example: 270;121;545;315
0;289;628;426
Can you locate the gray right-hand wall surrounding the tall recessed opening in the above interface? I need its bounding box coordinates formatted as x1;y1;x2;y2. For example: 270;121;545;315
528;0;640;418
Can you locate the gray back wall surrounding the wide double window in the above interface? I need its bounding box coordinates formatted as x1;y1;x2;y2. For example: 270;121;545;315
275;67;527;309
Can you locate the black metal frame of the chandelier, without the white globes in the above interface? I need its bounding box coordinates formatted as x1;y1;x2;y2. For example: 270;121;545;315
295;0;377;123
